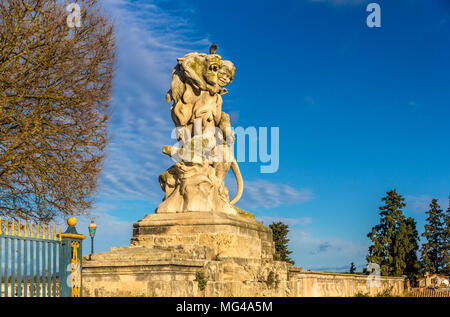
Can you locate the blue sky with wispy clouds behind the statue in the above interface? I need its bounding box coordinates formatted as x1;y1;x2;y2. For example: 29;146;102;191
74;0;450;271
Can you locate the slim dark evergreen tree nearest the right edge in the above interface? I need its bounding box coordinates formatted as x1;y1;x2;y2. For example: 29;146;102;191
421;198;448;274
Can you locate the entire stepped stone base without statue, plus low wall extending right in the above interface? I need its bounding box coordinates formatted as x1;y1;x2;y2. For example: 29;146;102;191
83;212;403;297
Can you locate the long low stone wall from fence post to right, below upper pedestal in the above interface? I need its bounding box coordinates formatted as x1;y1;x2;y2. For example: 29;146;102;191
83;258;404;297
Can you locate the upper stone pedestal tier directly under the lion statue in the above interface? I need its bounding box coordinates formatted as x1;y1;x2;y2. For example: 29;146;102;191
131;212;275;259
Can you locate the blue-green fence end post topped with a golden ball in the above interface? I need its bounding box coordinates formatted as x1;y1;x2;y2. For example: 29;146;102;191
58;218;86;297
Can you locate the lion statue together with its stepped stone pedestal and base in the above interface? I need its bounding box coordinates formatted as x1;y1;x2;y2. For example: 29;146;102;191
83;45;302;296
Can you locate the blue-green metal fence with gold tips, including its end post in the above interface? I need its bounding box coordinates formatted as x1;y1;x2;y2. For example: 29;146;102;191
0;218;84;297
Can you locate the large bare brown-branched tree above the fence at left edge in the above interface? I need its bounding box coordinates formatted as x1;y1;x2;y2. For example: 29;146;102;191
0;0;115;222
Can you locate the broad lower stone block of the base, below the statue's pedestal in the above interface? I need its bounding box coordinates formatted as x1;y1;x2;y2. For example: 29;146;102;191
83;246;290;297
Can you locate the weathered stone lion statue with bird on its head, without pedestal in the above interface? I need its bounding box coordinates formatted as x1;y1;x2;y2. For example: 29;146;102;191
156;44;244;214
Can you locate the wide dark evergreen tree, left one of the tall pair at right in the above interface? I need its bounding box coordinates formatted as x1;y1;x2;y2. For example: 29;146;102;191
366;189;407;276
